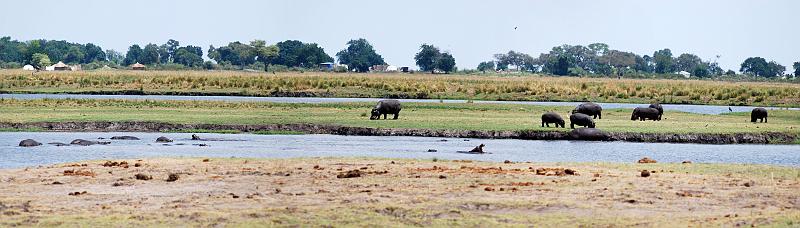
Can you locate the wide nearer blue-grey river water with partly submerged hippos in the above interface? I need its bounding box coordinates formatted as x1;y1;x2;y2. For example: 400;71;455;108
0;132;800;168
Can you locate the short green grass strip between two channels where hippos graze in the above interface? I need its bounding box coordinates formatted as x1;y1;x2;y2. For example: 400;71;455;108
0;99;800;134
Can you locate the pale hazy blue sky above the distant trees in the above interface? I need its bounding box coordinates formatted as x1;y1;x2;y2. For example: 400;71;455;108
0;0;800;71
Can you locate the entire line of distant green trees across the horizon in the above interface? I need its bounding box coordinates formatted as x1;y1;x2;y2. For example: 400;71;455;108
0;36;800;78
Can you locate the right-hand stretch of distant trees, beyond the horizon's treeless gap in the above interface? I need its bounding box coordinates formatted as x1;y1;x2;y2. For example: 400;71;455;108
477;43;800;78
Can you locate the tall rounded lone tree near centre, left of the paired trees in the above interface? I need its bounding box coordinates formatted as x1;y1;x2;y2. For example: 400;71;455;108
336;38;386;72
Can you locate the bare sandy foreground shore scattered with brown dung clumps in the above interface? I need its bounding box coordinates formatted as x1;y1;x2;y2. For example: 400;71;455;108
0;158;800;227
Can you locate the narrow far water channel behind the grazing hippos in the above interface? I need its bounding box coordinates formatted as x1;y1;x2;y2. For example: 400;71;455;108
0;94;800;114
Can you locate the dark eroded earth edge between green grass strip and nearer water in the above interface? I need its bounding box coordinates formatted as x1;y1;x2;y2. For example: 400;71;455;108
0;121;800;144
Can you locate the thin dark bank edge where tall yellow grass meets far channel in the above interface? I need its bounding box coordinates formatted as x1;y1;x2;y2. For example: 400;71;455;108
0;90;800;108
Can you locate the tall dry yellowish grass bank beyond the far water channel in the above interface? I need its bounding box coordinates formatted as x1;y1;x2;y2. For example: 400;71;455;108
0;70;800;107
